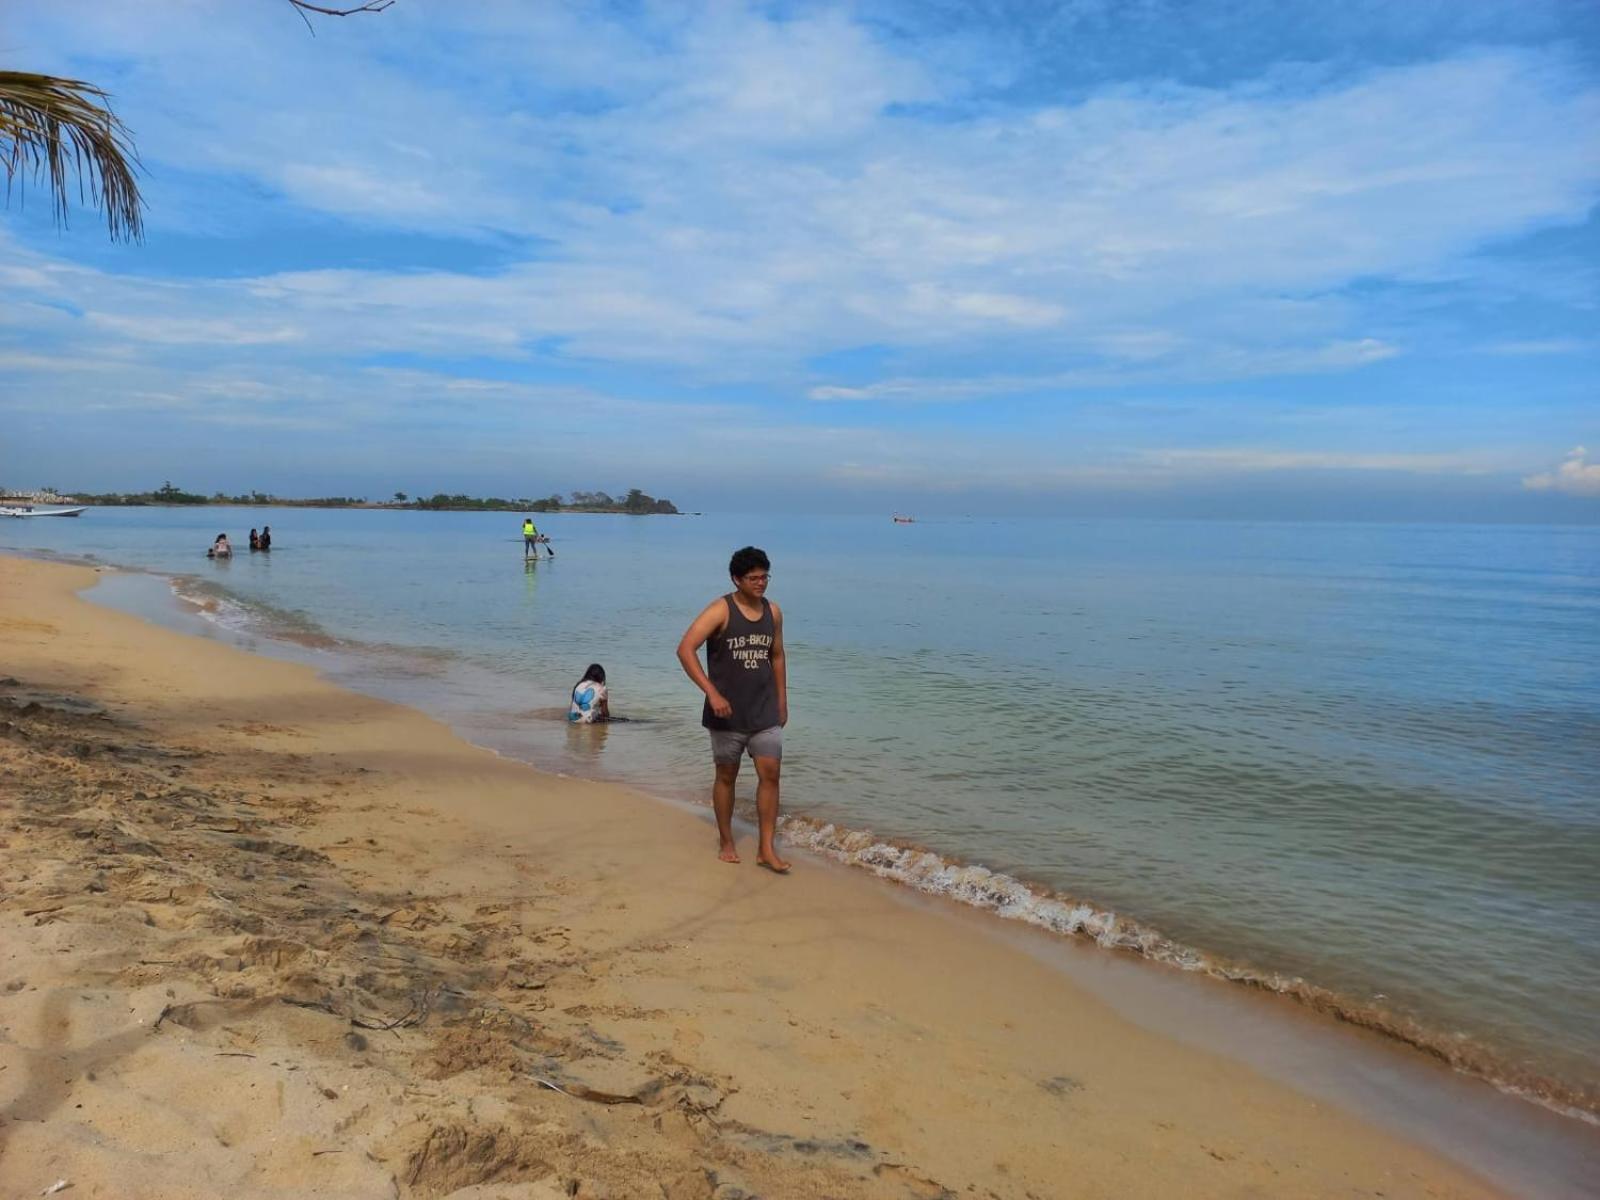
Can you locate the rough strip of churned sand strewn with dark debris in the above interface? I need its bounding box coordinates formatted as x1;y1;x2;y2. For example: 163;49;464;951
0;677;972;1200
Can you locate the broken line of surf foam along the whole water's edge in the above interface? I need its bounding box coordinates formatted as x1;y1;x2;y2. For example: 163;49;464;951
75;553;1600;1126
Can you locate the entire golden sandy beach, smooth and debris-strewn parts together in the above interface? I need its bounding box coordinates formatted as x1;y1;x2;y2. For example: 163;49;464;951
0;557;1496;1200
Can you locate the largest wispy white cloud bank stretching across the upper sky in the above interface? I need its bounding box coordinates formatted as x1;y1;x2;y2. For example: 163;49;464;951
6;3;1600;387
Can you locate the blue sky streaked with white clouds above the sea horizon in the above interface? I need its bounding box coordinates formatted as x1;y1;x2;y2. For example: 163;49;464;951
0;0;1600;522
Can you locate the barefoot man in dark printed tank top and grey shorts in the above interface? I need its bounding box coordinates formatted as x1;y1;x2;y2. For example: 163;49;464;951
678;546;789;875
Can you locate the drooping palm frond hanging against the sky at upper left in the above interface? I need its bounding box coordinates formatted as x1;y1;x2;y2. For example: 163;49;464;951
0;70;144;242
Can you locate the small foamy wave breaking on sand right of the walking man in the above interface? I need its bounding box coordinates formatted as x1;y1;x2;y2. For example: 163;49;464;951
781;816;1600;1125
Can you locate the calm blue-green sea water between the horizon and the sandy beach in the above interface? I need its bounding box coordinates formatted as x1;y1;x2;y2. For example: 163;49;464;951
0;509;1600;1104
